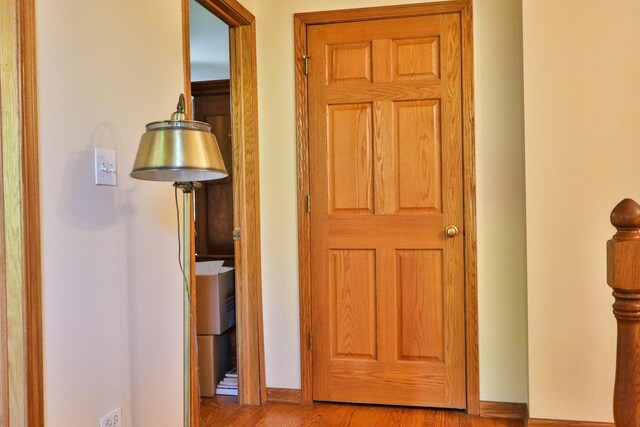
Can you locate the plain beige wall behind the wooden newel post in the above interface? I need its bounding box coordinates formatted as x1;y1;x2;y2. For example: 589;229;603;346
523;0;640;421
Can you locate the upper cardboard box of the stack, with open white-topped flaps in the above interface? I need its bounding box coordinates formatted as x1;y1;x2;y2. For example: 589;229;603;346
196;261;236;335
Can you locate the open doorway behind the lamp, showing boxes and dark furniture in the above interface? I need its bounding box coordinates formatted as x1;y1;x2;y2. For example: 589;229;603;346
189;0;238;408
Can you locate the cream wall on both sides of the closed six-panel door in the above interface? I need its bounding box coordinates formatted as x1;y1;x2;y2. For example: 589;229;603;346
251;0;527;402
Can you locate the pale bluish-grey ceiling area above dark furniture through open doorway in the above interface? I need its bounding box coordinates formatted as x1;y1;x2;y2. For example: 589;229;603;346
189;0;229;82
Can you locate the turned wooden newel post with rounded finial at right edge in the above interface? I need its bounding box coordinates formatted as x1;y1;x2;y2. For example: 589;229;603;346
607;199;640;427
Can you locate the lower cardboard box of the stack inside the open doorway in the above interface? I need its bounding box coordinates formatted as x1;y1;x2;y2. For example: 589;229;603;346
198;334;229;397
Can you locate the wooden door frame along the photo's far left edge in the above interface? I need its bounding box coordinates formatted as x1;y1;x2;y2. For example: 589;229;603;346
0;0;44;427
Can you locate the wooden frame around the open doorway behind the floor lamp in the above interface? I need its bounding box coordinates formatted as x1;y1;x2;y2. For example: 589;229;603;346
182;0;267;405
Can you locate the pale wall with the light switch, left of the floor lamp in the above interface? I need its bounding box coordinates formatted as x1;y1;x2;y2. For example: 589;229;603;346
36;0;182;427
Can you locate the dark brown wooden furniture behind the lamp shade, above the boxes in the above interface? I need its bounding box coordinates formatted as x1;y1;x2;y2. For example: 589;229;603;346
191;80;234;266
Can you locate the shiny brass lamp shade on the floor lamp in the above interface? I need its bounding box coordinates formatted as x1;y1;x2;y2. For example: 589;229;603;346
130;95;228;182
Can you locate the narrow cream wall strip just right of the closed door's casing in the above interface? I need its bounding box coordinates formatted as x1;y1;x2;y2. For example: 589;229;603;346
474;0;527;402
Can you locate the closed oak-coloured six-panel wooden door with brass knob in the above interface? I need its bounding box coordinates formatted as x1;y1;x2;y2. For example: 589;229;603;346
307;14;466;408
